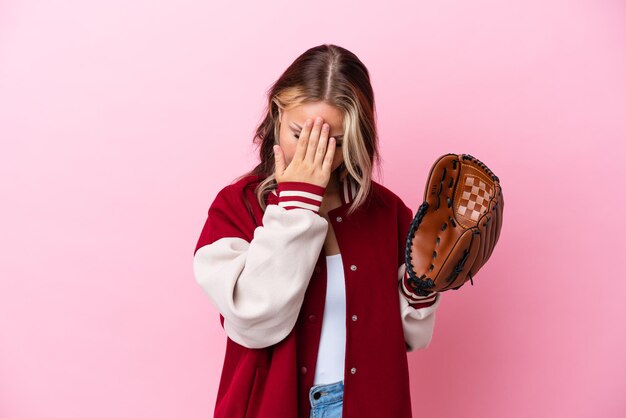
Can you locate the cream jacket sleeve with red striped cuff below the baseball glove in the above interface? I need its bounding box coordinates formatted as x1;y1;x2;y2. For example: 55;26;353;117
398;263;441;352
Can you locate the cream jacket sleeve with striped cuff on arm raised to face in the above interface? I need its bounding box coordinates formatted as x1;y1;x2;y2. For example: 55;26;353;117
193;182;328;348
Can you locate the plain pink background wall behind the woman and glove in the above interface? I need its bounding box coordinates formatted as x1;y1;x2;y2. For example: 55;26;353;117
0;0;626;418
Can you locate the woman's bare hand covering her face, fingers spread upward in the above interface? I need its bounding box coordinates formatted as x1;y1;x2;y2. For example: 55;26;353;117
274;117;335;188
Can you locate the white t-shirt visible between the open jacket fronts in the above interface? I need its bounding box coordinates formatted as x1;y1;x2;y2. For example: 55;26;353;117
313;254;346;385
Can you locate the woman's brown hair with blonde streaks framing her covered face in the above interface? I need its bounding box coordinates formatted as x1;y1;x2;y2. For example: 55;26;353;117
235;44;380;214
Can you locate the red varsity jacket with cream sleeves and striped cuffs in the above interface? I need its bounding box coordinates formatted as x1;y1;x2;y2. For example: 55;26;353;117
193;176;441;418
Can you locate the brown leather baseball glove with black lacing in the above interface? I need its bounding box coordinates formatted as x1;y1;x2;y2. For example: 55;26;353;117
403;154;504;297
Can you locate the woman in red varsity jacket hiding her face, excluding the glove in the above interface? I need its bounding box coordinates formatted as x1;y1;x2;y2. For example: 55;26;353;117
194;44;441;418
